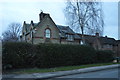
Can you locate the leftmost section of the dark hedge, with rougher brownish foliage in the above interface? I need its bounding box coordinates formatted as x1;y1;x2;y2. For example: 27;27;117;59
2;42;36;68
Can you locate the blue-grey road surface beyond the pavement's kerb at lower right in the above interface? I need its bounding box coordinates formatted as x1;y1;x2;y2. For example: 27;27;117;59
48;68;120;80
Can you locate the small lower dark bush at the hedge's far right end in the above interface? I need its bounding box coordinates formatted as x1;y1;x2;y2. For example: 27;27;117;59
96;50;114;63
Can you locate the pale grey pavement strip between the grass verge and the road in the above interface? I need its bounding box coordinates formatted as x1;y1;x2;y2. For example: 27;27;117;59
2;64;120;79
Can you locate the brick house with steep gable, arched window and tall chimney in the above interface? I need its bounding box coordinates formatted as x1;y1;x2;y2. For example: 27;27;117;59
22;12;81;44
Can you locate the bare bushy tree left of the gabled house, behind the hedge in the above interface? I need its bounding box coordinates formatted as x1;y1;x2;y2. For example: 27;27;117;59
2;23;21;41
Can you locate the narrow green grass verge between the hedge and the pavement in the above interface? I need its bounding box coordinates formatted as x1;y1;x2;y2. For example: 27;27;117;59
3;63;117;74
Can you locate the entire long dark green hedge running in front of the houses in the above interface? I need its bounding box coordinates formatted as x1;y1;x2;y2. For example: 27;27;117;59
2;42;112;69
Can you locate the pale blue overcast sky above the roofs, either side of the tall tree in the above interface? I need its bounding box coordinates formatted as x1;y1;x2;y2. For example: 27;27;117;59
0;0;118;39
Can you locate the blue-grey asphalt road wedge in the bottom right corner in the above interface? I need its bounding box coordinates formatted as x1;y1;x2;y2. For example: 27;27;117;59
57;68;120;80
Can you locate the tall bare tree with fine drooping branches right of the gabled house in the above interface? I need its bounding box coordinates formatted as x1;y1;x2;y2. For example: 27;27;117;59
64;0;104;42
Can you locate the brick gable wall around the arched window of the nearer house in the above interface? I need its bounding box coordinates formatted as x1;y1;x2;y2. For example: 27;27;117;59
33;16;60;44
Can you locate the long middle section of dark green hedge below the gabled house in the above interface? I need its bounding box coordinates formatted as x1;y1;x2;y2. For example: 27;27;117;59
37;44;96;68
